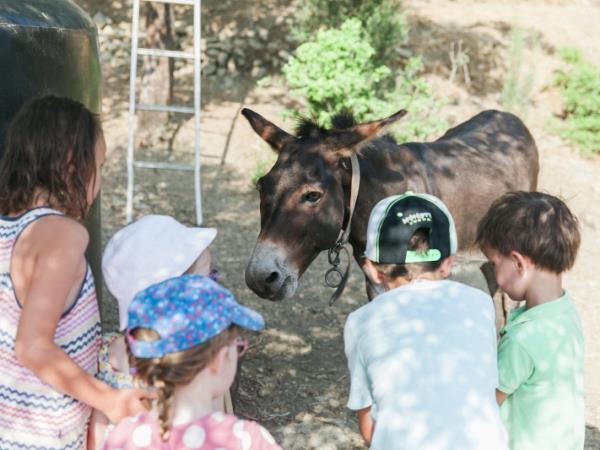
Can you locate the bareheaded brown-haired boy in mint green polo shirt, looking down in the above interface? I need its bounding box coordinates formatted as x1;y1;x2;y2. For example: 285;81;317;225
477;192;585;450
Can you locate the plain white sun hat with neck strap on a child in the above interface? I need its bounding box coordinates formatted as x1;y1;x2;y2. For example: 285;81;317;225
102;215;217;330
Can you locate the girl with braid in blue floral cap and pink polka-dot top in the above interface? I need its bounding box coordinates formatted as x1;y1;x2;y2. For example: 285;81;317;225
104;275;280;450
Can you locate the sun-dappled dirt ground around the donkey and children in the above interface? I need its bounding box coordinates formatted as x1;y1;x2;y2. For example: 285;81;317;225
84;0;600;449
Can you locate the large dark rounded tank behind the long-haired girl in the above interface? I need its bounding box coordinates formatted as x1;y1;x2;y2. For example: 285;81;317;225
0;0;102;295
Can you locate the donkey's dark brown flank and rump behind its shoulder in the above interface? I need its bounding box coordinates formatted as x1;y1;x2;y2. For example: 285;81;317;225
402;110;539;247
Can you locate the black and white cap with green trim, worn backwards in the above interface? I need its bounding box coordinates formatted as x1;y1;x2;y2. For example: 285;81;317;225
365;191;457;264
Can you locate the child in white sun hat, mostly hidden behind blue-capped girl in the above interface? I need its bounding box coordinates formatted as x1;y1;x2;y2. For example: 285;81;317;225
89;215;224;448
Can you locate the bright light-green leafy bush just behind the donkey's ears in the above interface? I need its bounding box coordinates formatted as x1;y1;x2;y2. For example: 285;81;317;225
283;19;445;140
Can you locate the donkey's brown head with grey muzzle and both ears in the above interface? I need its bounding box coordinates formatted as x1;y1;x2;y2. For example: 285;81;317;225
242;109;406;300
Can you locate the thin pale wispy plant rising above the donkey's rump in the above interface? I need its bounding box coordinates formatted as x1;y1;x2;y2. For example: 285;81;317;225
502;28;537;116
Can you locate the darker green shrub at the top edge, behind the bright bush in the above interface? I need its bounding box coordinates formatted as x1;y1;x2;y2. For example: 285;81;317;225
295;0;408;63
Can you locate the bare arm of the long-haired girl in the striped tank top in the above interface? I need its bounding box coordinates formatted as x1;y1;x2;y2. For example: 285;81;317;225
15;217;155;422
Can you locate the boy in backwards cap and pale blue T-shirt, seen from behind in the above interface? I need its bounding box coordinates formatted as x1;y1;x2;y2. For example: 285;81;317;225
344;192;507;450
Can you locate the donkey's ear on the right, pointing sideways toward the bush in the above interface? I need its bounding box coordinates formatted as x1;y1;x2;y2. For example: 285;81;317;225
328;109;407;153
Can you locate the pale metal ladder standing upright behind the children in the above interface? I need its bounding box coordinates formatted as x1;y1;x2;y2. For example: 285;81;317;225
126;0;202;225
